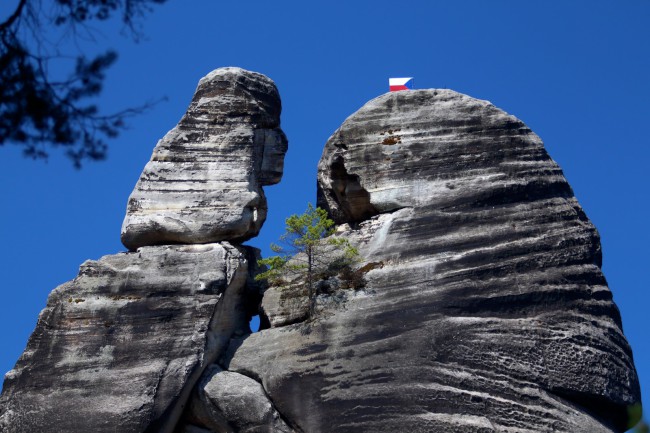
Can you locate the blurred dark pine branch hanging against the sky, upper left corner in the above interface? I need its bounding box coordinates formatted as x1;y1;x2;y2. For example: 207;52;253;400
0;0;165;167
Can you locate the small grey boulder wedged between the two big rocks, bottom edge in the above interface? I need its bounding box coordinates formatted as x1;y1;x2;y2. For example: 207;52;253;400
181;365;293;433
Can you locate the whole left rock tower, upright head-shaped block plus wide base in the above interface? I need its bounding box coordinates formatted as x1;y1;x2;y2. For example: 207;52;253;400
0;68;287;433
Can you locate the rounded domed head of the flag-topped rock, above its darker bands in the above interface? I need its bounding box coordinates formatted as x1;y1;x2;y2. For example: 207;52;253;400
317;89;540;223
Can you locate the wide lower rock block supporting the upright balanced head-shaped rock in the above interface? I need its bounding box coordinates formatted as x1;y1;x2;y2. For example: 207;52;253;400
0;242;253;433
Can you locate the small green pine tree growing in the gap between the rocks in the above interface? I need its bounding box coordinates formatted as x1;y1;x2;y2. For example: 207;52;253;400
255;203;359;318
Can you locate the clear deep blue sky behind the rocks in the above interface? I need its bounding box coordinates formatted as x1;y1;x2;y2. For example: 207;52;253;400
0;0;650;426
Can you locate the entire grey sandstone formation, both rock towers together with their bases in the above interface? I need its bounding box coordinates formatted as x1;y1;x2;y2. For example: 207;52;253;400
0;78;640;433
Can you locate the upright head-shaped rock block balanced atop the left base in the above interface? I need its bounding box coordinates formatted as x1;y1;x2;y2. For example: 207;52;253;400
122;68;287;250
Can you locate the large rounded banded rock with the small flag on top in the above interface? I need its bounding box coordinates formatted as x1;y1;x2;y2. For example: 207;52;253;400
224;90;640;433
